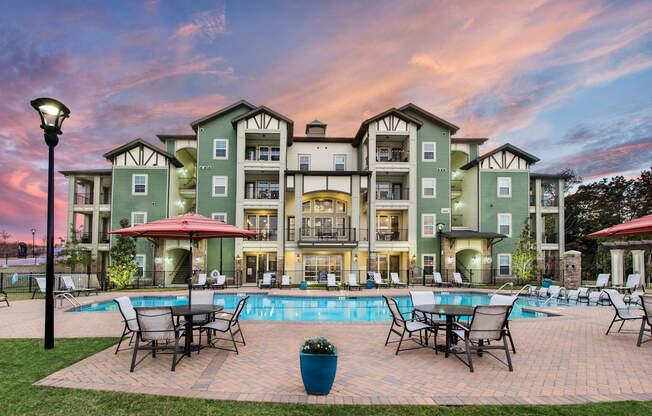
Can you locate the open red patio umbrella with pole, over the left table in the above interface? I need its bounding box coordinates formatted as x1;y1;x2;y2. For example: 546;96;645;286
109;213;256;306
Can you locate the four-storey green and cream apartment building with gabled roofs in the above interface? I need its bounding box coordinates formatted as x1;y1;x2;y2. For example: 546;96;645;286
62;100;564;284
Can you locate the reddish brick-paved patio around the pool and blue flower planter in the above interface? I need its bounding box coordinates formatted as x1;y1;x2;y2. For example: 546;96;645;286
0;290;652;405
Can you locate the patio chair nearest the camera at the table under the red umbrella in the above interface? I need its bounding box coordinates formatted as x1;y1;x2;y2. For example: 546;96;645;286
129;306;185;373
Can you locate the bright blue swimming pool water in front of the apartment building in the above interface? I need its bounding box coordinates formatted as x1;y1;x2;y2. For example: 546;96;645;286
69;292;572;322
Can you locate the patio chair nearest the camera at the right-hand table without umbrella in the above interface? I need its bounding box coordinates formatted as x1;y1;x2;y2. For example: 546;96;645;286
451;305;514;372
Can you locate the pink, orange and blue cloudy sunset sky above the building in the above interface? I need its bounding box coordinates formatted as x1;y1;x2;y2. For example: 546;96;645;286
0;0;652;240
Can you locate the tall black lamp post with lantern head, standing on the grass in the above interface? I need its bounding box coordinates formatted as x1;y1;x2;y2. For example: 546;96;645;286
30;98;70;350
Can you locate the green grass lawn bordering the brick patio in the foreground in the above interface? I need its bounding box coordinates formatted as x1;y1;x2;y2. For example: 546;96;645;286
0;338;652;416
